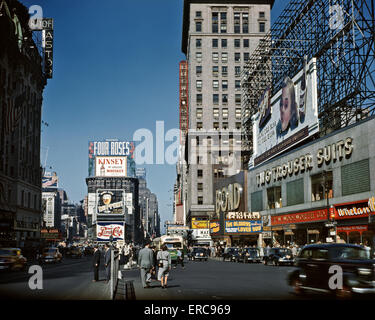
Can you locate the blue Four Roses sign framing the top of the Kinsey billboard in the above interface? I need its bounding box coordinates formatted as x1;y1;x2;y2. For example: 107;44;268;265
88;139;135;177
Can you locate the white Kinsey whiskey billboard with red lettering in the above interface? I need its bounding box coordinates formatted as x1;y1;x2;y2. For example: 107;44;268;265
95;157;127;177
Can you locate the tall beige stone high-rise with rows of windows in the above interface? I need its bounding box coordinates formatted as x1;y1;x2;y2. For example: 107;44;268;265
182;0;274;225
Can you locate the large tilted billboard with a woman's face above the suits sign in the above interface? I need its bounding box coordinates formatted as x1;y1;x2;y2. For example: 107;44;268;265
250;58;319;166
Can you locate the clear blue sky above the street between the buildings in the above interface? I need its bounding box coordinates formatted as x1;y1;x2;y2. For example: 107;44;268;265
21;0;287;231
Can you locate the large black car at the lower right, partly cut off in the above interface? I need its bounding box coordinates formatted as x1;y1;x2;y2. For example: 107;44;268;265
288;243;375;298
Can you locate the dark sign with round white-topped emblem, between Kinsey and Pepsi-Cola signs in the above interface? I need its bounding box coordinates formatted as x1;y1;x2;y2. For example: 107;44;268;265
97;190;125;214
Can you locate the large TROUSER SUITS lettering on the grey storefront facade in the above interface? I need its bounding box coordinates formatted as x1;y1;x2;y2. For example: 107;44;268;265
256;137;353;187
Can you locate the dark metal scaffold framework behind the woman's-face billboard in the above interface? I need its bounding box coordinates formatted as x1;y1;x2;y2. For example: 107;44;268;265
242;0;375;166
